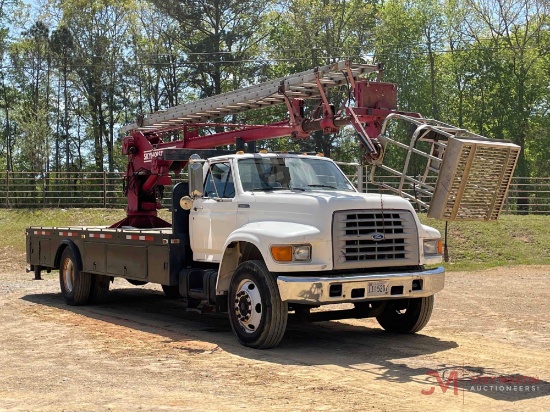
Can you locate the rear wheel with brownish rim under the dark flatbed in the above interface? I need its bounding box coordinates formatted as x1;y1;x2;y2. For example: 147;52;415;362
59;247;92;306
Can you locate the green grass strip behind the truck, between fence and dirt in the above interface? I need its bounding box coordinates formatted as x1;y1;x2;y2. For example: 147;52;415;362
0;209;550;270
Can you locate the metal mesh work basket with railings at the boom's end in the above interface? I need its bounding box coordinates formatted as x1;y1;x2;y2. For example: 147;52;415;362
370;114;521;221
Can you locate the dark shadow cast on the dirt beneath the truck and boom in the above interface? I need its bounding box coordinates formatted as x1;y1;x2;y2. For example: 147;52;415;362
22;288;550;401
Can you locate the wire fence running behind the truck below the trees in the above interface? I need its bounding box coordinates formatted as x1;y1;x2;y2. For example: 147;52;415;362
0;169;550;214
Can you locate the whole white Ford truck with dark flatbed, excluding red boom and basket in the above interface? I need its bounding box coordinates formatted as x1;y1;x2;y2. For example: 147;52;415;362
27;153;445;348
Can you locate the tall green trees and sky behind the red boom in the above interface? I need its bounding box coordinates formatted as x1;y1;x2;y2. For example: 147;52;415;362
0;0;550;182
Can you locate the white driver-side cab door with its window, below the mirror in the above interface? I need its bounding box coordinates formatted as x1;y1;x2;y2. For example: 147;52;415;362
189;161;237;262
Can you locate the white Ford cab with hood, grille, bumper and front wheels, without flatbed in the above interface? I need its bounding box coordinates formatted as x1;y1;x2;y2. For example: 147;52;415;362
188;153;445;348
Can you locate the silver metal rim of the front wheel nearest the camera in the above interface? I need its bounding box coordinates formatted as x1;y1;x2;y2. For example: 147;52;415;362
233;279;263;333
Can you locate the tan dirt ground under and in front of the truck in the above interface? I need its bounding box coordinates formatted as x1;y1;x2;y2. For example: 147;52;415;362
0;262;550;411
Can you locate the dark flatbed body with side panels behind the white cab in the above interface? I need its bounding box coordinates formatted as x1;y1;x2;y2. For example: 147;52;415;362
26;226;189;285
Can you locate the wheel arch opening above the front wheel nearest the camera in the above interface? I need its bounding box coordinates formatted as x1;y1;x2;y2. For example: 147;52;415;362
216;241;265;295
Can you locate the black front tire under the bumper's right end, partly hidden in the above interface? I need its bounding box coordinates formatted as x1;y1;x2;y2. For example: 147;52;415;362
376;295;434;333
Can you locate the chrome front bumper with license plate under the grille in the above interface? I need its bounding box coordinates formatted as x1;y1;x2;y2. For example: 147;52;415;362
277;266;445;305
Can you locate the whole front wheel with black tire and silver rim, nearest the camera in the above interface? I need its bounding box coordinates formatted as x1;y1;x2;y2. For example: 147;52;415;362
228;260;288;349
